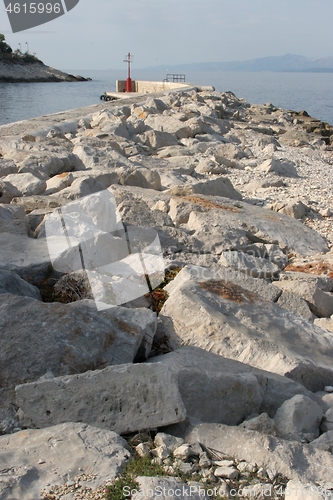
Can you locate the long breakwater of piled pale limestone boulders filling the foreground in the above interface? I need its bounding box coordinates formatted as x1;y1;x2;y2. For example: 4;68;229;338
0;90;333;500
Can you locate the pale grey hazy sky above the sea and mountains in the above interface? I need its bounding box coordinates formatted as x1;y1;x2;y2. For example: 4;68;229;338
0;0;333;70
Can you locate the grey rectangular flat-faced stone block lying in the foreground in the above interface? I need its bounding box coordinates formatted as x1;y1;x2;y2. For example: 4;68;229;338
15;363;186;434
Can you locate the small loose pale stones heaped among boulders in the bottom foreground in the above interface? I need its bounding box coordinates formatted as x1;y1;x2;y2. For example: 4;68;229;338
43;432;288;500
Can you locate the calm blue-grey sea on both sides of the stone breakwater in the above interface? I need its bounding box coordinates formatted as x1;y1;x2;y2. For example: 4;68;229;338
0;69;333;125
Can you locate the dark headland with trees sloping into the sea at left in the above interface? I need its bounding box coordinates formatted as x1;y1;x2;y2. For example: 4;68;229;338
0;33;87;83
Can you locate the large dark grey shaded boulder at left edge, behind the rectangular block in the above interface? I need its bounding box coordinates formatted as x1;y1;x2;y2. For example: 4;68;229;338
0;294;156;386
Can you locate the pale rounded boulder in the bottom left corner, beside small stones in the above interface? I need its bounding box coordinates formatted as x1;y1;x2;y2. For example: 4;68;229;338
0;423;130;500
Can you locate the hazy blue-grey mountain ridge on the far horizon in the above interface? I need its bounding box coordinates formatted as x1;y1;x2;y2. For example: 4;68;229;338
146;54;333;73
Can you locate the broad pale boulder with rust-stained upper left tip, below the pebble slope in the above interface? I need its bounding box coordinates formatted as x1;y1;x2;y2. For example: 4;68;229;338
182;195;327;255
